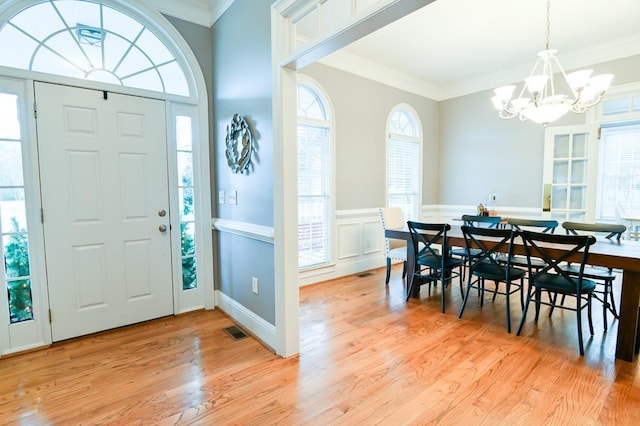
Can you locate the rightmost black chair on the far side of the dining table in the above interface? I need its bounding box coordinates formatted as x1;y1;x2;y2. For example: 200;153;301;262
562;222;627;331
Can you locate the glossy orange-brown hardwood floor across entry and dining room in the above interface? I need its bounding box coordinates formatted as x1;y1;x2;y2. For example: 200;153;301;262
0;267;640;425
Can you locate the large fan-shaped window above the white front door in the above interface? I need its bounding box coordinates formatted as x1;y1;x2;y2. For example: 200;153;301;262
0;0;190;96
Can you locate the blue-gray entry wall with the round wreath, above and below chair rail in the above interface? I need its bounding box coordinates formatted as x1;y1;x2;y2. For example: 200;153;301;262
211;0;275;324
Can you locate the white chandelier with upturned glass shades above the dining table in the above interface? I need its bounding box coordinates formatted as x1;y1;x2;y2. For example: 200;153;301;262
491;0;613;126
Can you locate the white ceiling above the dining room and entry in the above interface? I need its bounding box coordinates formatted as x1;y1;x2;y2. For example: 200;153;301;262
152;0;640;100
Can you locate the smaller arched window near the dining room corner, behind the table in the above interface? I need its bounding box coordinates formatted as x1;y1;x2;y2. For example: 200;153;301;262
387;105;422;220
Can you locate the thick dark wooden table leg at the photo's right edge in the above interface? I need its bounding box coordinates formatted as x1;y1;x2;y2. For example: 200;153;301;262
616;270;640;361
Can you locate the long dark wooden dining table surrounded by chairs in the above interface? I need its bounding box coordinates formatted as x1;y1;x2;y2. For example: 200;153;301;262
385;225;640;362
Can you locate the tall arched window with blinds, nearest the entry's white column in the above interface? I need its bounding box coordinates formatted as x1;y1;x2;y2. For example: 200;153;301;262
298;82;333;268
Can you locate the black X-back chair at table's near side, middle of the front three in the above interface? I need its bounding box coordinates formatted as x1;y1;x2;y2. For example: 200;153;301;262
458;225;525;333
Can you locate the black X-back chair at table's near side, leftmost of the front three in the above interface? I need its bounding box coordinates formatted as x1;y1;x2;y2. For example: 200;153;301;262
407;221;463;313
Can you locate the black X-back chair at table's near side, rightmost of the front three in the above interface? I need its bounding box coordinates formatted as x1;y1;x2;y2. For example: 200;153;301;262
516;231;596;355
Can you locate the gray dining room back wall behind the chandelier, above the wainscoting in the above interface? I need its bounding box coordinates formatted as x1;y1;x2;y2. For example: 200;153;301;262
439;55;640;208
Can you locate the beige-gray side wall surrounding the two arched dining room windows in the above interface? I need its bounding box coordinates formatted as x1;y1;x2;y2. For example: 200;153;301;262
300;64;440;210
